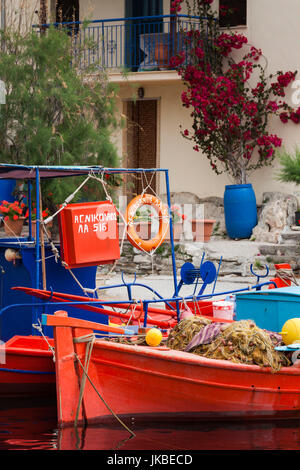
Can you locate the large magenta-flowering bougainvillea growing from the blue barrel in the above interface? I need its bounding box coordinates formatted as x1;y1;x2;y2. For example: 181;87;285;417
171;0;300;184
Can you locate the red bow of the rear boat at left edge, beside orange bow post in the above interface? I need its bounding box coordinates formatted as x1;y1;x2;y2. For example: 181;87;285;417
0;336;55;397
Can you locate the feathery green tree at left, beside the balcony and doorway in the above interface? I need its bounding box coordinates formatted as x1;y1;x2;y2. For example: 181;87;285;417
0;28;118;207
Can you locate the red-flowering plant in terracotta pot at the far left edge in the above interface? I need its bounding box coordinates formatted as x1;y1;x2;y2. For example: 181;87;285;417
0;201;26;236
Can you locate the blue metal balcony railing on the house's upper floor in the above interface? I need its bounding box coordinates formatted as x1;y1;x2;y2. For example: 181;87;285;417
33;15;215;72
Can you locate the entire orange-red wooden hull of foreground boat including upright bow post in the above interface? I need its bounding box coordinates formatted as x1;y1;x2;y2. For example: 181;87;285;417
48;316;300;425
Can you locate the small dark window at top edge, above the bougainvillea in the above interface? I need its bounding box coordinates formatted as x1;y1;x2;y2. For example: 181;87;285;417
219;0;247;28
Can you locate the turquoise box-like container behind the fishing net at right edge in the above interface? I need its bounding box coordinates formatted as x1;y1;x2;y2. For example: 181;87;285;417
236;286;300;332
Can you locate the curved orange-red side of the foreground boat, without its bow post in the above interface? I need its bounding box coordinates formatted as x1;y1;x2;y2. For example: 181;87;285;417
78;341;300;421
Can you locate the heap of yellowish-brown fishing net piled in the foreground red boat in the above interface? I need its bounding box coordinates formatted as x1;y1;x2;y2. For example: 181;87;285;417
167;317;291;372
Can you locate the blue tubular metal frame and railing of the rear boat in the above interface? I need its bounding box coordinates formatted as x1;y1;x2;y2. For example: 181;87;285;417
0;164;276;335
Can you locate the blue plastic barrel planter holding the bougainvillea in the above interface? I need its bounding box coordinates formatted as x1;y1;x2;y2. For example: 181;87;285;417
224;184;257;239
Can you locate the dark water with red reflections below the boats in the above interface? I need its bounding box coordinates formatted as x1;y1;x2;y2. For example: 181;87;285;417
0;400;300;451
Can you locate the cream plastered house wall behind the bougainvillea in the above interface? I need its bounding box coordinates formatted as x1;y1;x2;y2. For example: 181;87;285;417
81;0;300;202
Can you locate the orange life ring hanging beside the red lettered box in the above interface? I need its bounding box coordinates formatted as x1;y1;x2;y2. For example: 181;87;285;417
125;194;170;252
